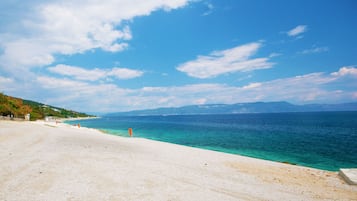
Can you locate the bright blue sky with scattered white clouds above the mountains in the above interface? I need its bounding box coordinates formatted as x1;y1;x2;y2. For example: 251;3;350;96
0;0;357;113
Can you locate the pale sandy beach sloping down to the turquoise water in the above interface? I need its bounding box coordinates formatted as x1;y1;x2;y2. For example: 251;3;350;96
0;121;357;201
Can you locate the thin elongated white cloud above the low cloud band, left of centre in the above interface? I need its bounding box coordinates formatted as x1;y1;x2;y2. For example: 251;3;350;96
48;64;144;81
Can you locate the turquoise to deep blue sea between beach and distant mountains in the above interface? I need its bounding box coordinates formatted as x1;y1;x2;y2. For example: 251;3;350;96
67;112;357;171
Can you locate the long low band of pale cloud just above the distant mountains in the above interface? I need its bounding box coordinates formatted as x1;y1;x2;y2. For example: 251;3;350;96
4;67;357;112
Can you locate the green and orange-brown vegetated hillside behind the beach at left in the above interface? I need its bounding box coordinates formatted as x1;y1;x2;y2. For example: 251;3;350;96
0;93;91;121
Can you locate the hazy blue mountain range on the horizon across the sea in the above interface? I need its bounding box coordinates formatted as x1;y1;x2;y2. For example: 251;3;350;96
106;102;357;116
